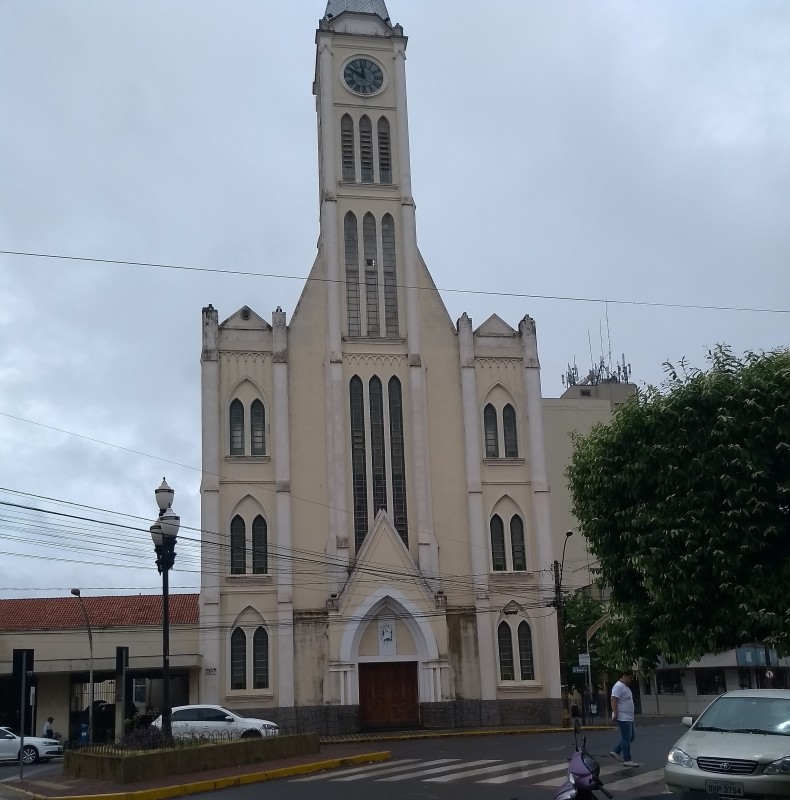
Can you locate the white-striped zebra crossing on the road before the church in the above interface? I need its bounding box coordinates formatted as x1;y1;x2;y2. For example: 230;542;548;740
290;758;664;791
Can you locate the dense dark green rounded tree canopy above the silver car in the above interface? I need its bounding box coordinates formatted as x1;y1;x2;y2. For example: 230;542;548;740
567;346;790;663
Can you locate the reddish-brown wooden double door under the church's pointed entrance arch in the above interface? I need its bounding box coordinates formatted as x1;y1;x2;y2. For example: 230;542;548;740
359;661;420;730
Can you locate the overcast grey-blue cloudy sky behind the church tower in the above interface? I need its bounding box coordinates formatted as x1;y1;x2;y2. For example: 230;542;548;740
0;0;790;596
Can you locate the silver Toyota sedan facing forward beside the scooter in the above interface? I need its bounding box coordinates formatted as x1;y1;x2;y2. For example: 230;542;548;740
664;689;790;797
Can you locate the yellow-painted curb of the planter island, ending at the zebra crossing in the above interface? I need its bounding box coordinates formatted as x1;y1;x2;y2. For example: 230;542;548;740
3;750;392;800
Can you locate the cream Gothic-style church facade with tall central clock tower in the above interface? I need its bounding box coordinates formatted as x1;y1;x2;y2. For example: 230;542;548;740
200;0;565;732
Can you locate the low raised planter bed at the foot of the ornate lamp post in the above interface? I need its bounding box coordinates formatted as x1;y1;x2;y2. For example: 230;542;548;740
63;733;321;783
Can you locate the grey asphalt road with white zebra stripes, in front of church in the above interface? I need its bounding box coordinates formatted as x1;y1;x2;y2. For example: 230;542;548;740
206;720;684;800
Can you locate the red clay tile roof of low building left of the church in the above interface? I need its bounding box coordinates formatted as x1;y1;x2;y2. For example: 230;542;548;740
0;594;199;631
